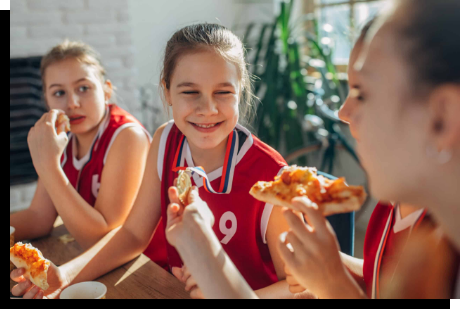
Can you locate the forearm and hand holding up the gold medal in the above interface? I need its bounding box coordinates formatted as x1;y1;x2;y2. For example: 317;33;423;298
166;187;257;299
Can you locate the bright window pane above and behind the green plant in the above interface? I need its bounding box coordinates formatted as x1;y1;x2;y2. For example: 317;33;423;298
316;0;386;65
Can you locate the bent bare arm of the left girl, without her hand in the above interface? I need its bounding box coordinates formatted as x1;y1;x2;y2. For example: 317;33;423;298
40;128;149;248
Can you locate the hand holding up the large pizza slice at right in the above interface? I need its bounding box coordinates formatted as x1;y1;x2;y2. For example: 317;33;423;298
278;197;354;298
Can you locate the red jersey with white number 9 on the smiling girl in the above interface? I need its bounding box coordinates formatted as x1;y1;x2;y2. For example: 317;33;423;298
145;121;286;290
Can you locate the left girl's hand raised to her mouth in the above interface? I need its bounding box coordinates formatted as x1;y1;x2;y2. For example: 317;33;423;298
27;109;68;177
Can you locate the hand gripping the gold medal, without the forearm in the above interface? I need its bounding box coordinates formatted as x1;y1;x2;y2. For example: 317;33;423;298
166;187;214;246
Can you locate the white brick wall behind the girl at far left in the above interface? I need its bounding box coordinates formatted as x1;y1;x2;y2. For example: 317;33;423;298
5;0;142;210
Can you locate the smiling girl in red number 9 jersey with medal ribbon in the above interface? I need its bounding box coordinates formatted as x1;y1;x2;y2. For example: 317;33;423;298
11;24;298;298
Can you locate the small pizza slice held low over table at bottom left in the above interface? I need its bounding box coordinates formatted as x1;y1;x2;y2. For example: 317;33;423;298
10;242;50;291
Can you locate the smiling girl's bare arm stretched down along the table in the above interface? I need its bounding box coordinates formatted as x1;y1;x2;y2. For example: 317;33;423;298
11;126;164;297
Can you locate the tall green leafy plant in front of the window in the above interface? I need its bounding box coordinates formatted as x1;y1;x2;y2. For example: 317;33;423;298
244;0;358;172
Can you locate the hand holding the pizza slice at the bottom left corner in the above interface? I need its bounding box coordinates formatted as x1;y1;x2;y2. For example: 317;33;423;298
10;263;69;299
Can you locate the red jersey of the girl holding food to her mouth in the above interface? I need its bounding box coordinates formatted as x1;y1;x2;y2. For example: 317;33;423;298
61;105;151;206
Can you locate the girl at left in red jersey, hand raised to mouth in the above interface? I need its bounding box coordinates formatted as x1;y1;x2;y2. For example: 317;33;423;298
10;41;150;248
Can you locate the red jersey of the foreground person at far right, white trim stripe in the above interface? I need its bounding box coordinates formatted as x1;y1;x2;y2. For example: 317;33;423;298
363;203;425;298
